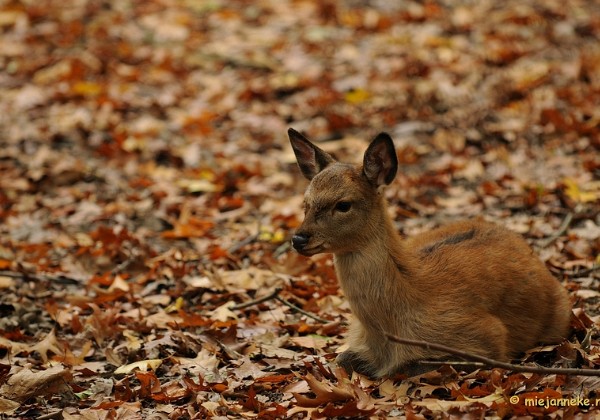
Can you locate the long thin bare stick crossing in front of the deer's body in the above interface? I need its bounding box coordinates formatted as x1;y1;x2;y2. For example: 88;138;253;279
384;333;600;376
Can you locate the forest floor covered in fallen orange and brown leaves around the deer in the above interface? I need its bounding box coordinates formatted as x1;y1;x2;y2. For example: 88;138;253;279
0;0;600;419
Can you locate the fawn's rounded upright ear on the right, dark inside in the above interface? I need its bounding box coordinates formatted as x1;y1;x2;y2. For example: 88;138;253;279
363;133;398;187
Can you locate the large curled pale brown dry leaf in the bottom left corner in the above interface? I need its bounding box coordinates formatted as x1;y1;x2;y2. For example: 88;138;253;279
0;366;73;403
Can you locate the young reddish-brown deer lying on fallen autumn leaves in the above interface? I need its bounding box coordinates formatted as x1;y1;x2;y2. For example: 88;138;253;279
288;129;571;377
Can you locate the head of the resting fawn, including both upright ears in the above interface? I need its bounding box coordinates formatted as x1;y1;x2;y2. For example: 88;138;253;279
288;129;398;256
